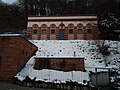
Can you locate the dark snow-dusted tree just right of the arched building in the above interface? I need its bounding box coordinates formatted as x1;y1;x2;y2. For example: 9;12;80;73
99;13;120;40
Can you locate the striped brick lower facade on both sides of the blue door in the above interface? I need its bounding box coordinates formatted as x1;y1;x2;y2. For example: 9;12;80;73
27;27;100;40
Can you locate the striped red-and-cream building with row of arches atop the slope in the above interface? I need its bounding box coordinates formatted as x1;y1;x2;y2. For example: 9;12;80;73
27;16;99;40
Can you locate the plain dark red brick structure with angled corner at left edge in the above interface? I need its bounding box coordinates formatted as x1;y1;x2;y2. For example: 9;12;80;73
0;35;37;82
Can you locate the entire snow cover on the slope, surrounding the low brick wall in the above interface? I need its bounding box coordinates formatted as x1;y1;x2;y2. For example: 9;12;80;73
16;40;120;84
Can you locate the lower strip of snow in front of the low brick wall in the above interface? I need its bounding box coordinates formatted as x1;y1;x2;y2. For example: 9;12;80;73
15;57;90;85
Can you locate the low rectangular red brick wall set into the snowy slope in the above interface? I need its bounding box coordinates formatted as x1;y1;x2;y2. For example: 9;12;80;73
34;58;85;71
